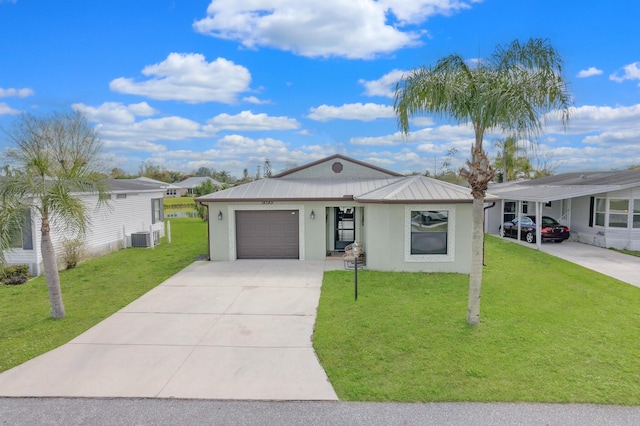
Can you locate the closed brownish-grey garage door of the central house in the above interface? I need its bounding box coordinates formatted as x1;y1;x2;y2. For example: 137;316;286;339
236;210;299;259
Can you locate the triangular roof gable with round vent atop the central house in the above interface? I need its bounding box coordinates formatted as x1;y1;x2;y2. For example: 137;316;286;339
272;154;402;179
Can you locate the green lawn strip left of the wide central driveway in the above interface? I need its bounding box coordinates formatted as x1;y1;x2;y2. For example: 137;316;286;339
0;219;207;372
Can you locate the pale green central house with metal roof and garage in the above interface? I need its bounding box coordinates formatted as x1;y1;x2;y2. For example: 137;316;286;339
196;155;488;273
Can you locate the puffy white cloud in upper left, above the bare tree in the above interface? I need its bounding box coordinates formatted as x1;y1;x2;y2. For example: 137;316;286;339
109;53;251;103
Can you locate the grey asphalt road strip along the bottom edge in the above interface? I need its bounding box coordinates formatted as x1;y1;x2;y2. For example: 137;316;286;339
0;398;640;426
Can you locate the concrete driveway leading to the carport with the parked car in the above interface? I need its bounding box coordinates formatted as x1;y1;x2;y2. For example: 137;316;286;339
505;238;640;287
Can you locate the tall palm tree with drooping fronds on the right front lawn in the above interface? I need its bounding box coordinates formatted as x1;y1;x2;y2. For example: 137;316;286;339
394;39;571;324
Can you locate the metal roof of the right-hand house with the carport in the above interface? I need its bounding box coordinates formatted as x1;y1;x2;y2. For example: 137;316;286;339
488;170;640;202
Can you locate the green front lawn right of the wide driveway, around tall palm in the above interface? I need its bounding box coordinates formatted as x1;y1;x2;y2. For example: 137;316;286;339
314;237;640;405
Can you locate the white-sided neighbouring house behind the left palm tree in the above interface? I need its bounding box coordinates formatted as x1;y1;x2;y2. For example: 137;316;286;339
5;179;165;275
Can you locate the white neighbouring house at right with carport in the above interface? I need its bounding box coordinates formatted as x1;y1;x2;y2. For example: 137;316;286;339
485;170;640;250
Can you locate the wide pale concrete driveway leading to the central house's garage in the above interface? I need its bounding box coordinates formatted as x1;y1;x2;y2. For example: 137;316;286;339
0;260;338;400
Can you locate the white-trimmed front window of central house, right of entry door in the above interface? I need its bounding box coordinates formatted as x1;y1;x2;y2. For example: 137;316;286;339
411;210;449;255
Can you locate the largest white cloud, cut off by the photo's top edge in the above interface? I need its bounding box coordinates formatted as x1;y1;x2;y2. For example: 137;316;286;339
193;0;476;59
